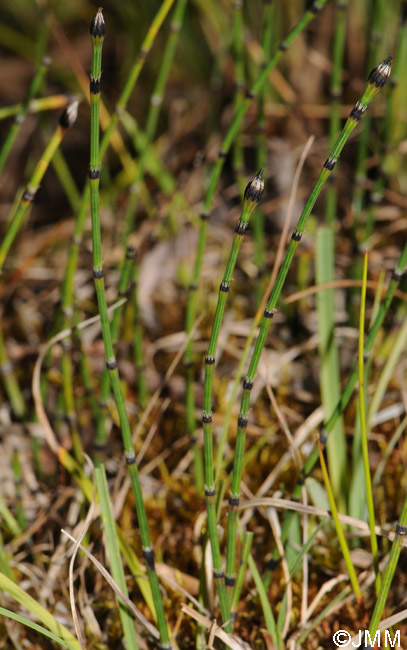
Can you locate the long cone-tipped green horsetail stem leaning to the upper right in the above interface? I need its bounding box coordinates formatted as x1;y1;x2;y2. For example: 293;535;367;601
226;56;393;591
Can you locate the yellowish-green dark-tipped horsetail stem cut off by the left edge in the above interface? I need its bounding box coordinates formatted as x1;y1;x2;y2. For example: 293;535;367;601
0;101;78;271
